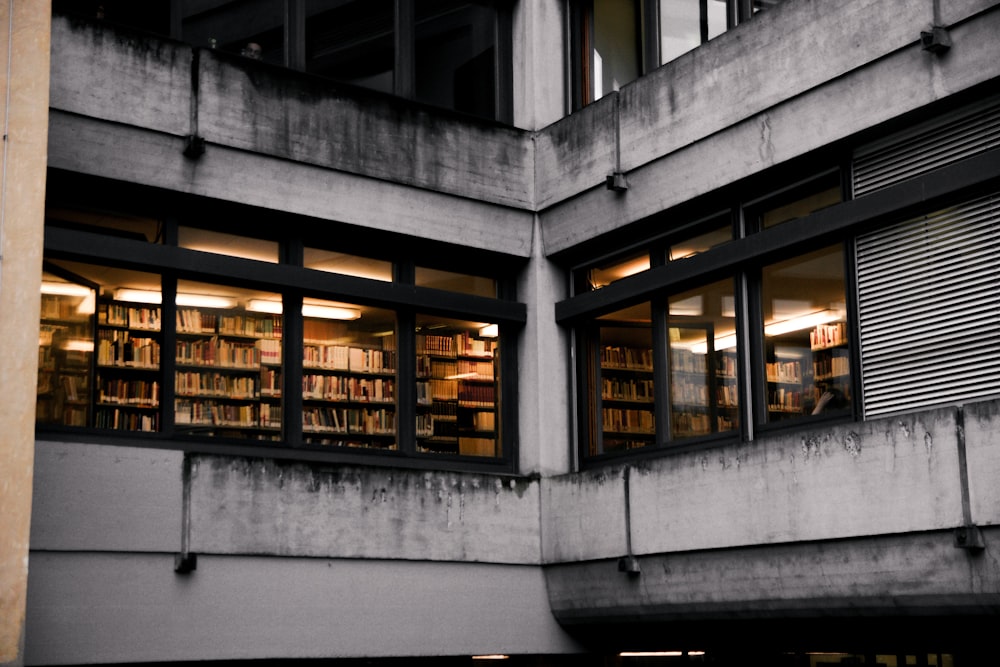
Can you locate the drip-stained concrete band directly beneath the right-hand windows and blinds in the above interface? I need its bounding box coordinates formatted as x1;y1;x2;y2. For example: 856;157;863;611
542;403;1000;563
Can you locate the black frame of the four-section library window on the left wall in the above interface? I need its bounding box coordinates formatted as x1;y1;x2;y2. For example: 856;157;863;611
36;170;527;473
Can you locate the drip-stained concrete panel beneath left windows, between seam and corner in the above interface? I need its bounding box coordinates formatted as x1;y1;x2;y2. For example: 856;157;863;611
191;456;540;564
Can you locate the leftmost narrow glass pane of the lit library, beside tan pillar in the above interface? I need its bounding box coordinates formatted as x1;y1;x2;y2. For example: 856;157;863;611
35;272;97;426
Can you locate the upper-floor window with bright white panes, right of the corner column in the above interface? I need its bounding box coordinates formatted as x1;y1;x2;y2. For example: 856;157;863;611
570;0;780;109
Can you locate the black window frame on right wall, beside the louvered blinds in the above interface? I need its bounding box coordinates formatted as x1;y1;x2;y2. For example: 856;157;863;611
555;150;1000;467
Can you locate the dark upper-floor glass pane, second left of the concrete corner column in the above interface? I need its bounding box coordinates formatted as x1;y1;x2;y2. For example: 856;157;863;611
306;0;395;93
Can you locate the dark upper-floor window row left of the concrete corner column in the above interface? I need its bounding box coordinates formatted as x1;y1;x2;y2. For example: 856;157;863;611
53;0;513;122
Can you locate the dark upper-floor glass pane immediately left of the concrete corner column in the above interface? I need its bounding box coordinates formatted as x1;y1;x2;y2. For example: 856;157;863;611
414;0;497;118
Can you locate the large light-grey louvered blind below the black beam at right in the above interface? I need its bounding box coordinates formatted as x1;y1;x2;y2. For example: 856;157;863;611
857;194;1000;417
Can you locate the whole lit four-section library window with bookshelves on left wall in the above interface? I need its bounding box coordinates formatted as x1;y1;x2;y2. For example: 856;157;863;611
37;188;525;467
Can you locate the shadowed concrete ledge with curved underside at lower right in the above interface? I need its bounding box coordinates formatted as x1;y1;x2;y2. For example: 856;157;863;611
545;528;1000;625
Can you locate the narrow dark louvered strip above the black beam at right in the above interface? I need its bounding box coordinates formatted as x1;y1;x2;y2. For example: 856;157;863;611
854;97;1000;197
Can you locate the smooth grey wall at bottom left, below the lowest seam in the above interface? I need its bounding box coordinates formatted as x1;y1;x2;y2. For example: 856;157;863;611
25;552;578;665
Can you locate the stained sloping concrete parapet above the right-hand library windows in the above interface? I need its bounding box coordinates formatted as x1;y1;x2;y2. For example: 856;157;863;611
536;0;1000;254
